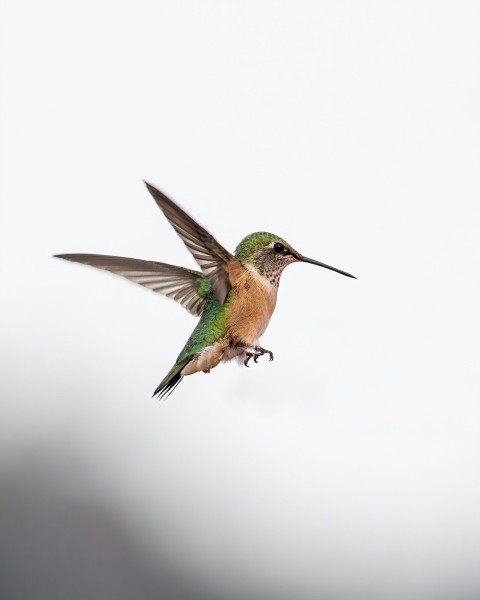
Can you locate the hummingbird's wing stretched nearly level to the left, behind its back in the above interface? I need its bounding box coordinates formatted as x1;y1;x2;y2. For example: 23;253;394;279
56;254;211;316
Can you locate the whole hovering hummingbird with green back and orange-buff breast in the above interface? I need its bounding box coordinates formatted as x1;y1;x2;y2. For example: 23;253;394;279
55;182;356;398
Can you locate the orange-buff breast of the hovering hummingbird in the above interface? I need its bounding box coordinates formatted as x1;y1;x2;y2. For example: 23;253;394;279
227;261;277;345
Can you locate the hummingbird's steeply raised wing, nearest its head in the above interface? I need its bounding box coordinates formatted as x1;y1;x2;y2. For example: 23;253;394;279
145;182;233;304
